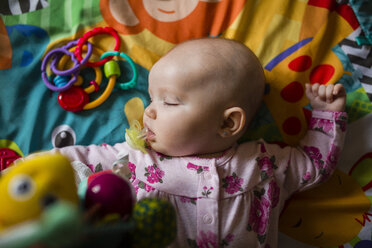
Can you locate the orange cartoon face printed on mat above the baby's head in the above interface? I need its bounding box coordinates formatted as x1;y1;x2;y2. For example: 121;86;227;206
100;0;245;43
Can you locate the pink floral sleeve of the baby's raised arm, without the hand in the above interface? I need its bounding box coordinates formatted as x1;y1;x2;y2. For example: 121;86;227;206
266;110;347;194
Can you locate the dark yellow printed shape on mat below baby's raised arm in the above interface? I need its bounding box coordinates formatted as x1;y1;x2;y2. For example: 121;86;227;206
279;153;372;247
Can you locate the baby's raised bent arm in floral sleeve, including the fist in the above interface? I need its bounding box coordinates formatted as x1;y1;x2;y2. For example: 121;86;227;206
268;84;347;194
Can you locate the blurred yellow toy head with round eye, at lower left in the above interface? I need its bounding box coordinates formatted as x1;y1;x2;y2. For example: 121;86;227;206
0;155;78;230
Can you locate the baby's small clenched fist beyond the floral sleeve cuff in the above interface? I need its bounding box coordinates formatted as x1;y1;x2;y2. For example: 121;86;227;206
305;83;346;112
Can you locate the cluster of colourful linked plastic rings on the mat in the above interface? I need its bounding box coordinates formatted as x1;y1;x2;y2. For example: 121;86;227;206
41;27;138;112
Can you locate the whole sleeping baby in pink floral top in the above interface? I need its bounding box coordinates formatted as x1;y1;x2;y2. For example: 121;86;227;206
37;38;347;248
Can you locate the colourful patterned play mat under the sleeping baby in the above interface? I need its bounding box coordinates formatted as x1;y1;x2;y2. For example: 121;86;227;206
0;0;372;248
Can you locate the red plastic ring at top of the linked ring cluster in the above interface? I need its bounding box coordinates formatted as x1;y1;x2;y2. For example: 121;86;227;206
75;27;120;67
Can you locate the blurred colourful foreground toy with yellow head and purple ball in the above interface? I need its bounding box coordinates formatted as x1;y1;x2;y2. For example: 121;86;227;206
0;154;177;248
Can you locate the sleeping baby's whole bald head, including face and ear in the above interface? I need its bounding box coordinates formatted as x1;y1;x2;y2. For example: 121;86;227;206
144;38;265;156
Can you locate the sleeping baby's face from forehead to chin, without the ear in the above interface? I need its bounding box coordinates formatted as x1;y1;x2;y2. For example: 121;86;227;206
143;57;223;156
